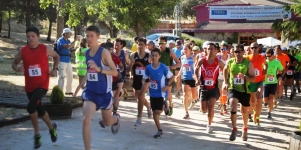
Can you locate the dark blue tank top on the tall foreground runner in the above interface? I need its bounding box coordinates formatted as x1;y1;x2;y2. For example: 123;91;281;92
84;47;112;95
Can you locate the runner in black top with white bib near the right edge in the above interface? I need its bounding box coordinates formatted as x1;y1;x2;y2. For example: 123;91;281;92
282;47;297;100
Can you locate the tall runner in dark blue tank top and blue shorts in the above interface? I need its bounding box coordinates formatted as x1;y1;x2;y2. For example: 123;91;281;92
82;26;120;149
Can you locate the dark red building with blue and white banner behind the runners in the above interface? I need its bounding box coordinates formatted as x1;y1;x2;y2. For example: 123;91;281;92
192;0;300;45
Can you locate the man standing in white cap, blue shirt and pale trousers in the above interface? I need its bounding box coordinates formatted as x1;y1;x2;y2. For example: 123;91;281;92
57;28;80;95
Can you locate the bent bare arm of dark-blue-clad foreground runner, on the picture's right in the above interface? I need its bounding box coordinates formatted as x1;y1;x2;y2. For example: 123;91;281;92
101;49;118;77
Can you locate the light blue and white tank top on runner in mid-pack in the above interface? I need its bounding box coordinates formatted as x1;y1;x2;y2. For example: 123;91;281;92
181;55;194;80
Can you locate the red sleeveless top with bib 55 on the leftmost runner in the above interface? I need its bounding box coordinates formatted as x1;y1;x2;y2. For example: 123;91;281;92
21;44;49;92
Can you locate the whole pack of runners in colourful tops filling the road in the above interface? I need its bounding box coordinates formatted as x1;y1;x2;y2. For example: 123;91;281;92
12;26;301;149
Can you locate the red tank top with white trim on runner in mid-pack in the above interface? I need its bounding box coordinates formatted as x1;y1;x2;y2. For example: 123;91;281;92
201;57;219;89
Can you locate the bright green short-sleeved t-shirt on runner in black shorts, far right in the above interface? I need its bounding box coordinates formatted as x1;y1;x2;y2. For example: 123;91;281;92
264;59;283;84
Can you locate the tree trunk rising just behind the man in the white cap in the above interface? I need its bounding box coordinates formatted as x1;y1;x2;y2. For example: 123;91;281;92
56;0;65;38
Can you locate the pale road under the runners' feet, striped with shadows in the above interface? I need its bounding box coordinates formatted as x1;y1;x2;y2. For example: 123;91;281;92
0;96;301;150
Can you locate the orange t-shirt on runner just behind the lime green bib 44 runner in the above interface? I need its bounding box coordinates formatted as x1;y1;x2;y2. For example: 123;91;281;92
245;54;266;82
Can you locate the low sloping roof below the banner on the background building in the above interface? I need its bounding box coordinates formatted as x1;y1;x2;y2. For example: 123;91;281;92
196;22;273;32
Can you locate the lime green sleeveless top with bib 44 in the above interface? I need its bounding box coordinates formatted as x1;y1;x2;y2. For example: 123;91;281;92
228;58;250;93
